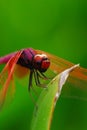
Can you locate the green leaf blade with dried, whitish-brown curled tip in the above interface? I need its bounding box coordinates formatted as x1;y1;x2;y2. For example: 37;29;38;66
31;65;79;130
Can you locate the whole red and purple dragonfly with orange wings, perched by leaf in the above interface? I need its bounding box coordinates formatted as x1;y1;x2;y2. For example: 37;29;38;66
0;48;87;106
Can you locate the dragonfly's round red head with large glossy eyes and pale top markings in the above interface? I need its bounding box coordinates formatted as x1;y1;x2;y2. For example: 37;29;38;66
33;54;50;72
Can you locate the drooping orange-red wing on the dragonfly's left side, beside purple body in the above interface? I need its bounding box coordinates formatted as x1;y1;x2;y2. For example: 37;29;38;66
0;51;22;107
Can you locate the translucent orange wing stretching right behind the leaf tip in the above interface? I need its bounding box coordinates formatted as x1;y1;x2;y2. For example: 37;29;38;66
36;50;87;99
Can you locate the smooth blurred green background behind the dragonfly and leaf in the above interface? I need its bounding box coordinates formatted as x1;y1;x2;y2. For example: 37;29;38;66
0;0;87;130
